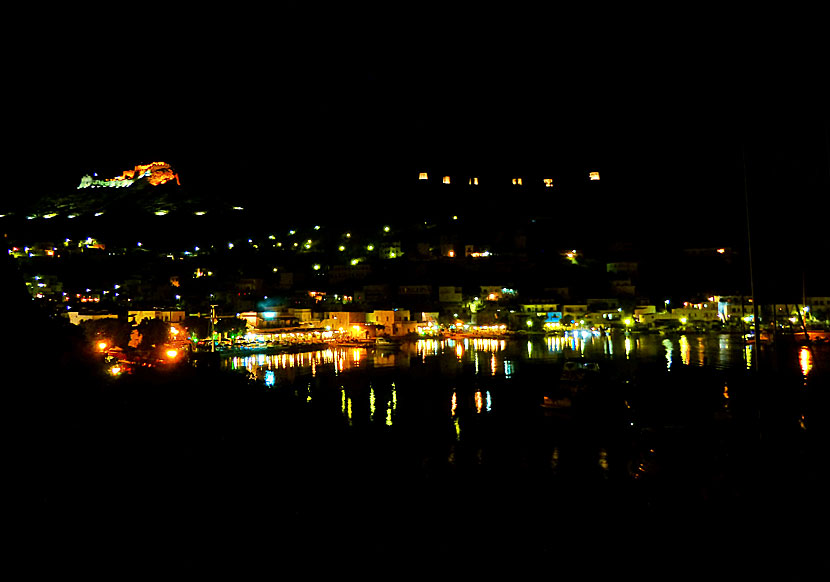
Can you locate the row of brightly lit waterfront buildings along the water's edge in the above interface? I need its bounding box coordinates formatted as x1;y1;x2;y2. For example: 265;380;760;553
65;287;830;341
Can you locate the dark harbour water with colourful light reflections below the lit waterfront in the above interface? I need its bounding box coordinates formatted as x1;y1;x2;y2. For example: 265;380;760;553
24;332;830;580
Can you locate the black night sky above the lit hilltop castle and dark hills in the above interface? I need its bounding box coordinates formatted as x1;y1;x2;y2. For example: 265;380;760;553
2;11;830;278
